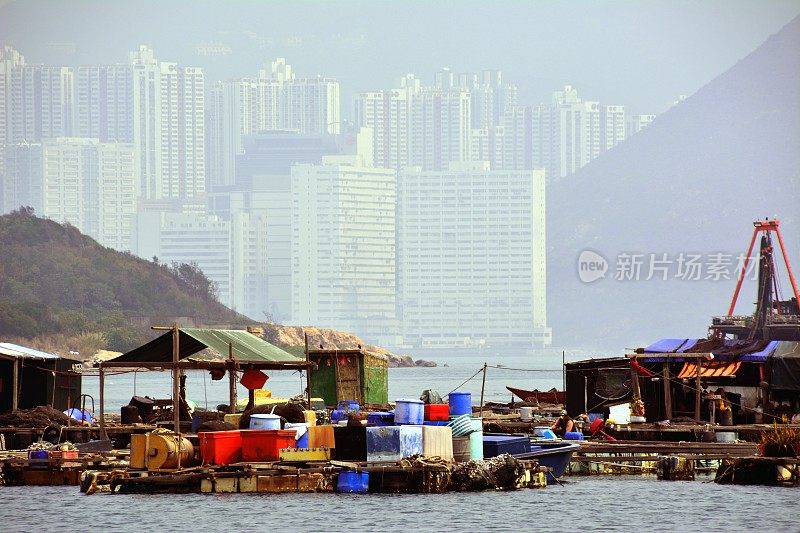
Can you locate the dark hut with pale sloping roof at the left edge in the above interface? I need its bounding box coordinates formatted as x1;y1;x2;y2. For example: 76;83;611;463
0;342;81;413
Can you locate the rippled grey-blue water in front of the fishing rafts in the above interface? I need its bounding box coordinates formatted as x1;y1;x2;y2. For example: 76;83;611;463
0;476;800;533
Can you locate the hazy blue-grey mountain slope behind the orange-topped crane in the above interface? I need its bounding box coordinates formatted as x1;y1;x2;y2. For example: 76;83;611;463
548;14;800;350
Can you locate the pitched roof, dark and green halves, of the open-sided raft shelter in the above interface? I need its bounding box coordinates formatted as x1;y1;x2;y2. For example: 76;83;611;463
110;328;306;367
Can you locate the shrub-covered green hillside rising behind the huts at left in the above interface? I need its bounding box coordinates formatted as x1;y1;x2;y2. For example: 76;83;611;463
0;209;252;355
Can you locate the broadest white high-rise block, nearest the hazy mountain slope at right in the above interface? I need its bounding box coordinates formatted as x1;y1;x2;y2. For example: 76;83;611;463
397;162;551;349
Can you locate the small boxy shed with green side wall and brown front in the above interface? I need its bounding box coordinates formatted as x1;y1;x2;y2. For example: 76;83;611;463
308;349;389;407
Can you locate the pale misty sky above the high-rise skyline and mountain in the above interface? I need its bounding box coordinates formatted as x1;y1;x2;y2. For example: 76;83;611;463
0;0;800;117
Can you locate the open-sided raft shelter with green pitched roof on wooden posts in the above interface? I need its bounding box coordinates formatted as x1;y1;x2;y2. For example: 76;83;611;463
98;325;314;433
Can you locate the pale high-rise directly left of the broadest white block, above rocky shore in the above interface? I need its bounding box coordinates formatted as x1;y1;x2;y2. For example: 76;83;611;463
292;156;398;344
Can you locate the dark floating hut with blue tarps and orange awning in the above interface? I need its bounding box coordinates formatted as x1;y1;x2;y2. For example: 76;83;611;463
565;338;800;424
